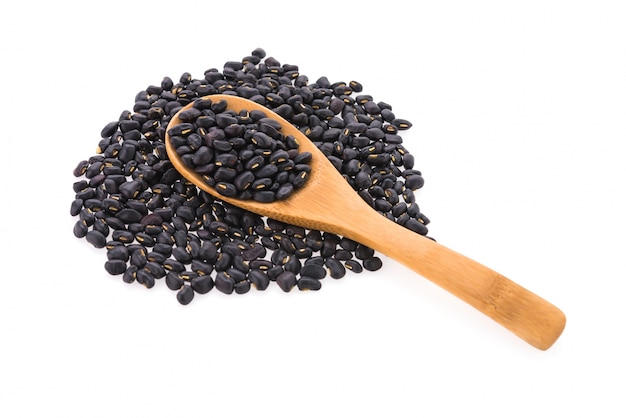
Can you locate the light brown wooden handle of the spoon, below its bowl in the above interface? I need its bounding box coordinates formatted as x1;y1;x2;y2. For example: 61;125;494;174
344;212;565;350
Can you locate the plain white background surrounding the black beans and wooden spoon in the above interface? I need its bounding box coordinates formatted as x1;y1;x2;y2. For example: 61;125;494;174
0;0;626;418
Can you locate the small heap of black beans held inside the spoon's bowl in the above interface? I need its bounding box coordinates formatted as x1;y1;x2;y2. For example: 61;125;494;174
168;98;311;203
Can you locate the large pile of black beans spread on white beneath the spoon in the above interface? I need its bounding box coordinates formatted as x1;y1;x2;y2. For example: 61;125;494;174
70;48;429;304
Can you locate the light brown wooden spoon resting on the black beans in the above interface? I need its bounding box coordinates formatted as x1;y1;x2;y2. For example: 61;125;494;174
165;95;565;350
